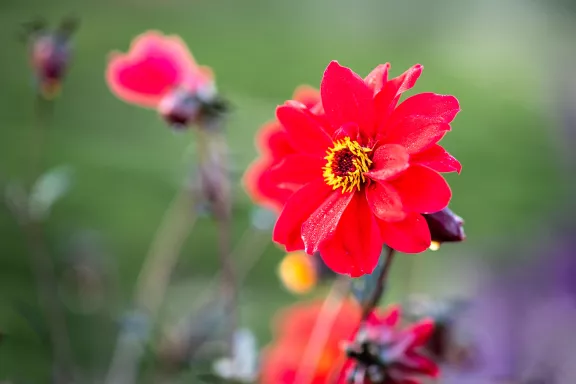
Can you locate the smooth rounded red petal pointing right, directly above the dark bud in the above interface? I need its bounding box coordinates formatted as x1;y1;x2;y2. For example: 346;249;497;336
390;165;452;213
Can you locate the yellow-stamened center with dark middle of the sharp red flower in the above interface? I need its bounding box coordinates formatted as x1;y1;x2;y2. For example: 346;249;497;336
323;137;372;193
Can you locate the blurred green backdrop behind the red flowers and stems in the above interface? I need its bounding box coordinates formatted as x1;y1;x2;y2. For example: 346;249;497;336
0;0;575;383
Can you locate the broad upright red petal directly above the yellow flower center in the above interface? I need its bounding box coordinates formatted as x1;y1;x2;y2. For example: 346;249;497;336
320;61;375;137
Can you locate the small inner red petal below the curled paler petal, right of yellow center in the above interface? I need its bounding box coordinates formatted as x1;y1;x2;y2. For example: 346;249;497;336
366;182;406;221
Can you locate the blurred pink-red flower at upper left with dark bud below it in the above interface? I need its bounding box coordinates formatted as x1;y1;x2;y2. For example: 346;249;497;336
106;31;219;127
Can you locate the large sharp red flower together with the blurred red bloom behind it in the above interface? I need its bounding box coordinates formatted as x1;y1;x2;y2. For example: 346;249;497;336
245;61;461;277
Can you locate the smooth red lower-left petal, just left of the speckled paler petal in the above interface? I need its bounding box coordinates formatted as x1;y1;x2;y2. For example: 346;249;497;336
272;179;332;252
